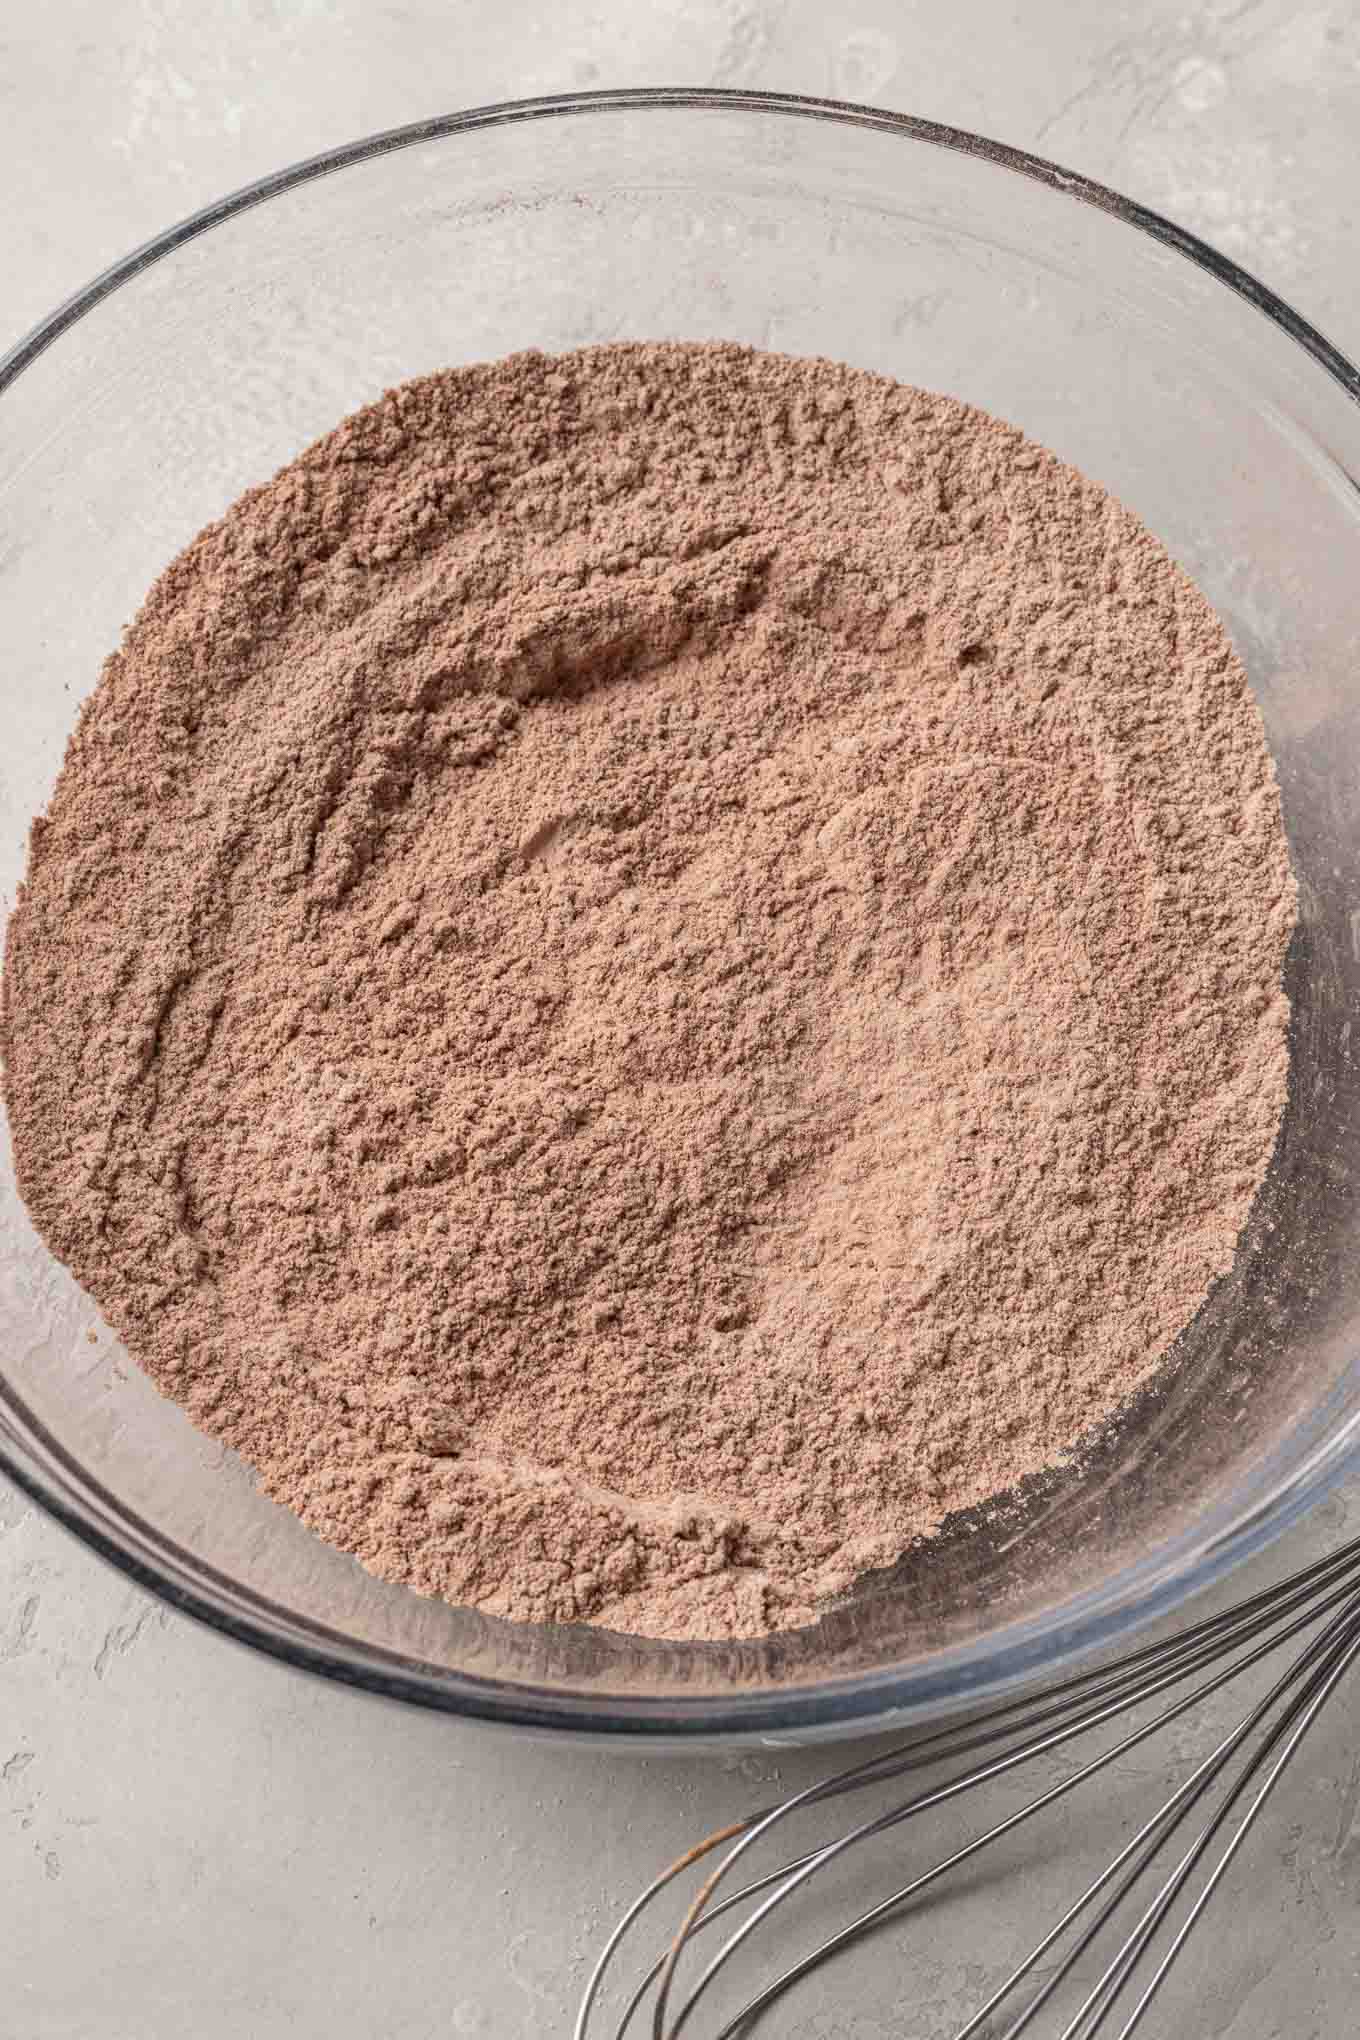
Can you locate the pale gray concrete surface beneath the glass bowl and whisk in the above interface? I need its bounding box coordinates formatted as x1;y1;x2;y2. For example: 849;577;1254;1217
0;0;1360;2040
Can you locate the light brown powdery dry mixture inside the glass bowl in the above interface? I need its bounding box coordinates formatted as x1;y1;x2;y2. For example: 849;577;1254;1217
4;345;1295;1636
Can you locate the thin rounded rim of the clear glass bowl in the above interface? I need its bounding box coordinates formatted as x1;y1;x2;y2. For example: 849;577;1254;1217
0;86;1360;1750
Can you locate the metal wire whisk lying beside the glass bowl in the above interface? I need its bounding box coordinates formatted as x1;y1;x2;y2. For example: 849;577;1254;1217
575;1538;1360;2040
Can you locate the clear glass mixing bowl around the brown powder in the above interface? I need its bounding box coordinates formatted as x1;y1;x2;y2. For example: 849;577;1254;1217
0;90;1360;1742
